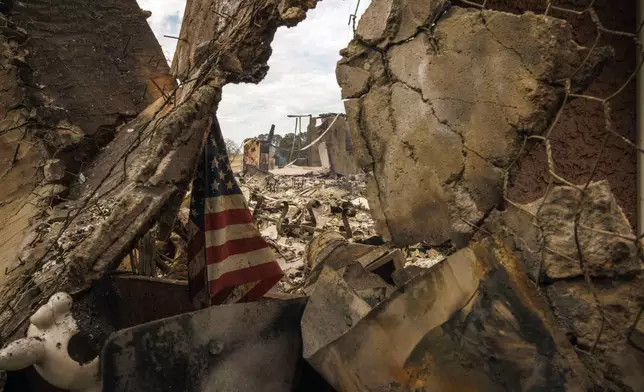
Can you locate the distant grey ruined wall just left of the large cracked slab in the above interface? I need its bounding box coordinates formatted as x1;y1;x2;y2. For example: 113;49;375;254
308;113;360;175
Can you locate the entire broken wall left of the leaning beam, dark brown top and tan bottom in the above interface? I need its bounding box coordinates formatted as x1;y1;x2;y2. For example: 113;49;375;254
0;0;176;290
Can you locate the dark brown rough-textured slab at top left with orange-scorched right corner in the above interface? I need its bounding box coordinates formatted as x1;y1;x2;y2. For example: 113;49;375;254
11;0;176;136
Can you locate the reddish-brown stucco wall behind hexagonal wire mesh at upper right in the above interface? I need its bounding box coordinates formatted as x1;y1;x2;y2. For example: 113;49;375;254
470;0;638;228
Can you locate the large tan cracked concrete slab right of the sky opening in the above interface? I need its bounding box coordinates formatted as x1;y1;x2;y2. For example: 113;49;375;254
336;0;612;247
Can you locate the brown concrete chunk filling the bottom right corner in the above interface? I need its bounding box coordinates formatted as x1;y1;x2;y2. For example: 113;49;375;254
546;274;644;391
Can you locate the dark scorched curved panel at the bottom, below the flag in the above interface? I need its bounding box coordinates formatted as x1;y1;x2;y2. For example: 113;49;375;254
102;299;306;392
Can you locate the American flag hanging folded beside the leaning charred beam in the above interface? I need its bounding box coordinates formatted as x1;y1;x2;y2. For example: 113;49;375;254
188;118;283;308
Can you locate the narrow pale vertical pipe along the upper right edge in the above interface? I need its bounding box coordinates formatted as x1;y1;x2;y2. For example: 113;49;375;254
634;0;644;237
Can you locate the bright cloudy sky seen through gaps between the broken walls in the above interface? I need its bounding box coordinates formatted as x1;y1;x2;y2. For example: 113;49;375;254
138;0;370;142
